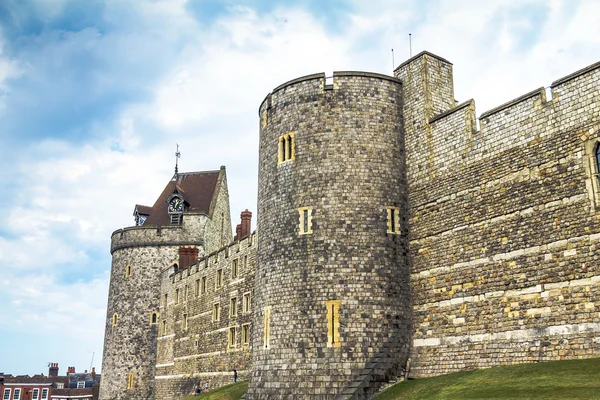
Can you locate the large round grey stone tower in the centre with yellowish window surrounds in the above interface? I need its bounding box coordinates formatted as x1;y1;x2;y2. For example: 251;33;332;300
247;72;411;399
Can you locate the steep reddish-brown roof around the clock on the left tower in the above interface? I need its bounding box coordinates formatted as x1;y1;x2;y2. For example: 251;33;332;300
144;167;225;226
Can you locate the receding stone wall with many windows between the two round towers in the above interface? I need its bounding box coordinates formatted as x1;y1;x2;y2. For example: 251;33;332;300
155;235;257;400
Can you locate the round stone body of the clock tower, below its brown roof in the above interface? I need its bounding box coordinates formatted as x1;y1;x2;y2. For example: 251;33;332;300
100;219;212;400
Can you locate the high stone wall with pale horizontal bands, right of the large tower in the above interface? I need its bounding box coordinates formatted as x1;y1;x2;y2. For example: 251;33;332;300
404;54;600;377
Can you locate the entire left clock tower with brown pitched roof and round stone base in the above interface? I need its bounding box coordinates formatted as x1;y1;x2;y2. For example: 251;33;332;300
100;167;232;400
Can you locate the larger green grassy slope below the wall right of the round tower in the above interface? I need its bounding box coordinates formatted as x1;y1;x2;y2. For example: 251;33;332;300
376;358;600;400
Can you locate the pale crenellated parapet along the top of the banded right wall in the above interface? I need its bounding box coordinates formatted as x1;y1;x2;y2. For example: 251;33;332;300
409;57;600;191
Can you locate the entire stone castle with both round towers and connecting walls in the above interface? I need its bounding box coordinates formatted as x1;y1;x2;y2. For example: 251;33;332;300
100;52;600;400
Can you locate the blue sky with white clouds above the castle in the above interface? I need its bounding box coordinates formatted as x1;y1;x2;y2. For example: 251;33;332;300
0;0;600;374
